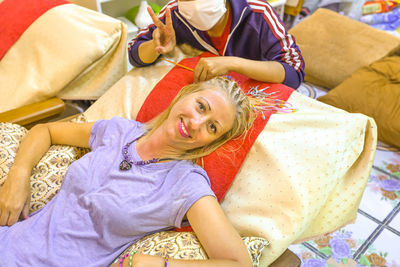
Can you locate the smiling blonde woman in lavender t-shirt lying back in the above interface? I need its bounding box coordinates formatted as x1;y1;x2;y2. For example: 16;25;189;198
0;78;254;267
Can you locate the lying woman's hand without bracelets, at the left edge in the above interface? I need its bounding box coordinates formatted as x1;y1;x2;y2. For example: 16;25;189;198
0;168;31;226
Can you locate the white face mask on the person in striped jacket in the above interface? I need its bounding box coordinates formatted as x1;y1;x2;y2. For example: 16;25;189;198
178;0;226;31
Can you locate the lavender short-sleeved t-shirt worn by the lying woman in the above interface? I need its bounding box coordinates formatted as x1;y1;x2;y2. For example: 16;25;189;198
0;117;215;267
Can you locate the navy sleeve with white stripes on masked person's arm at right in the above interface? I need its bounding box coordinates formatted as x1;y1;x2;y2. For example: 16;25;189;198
248;0;304;88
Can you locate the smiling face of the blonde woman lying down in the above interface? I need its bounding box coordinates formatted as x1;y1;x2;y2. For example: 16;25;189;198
164;89;235;151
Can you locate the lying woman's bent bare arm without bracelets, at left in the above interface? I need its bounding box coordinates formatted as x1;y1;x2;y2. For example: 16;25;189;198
0;122;93;226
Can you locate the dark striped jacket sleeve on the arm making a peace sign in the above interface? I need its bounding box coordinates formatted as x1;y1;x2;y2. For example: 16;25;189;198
128;0;178;67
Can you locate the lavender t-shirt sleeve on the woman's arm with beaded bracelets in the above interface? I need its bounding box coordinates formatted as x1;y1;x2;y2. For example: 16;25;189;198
172;167;216;228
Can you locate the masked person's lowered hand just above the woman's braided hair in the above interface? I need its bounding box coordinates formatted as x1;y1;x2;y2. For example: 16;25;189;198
193;56;234;82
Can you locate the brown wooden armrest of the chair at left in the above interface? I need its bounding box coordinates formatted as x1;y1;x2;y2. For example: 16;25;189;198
0;97;65;126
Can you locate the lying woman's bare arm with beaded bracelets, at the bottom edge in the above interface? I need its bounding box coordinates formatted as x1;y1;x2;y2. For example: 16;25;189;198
112;196;252;267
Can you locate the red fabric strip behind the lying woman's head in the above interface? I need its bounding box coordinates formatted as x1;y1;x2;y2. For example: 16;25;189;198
136;53;293;202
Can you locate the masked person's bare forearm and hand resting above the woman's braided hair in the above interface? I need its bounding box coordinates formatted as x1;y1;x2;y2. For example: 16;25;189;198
193;56;285;83
